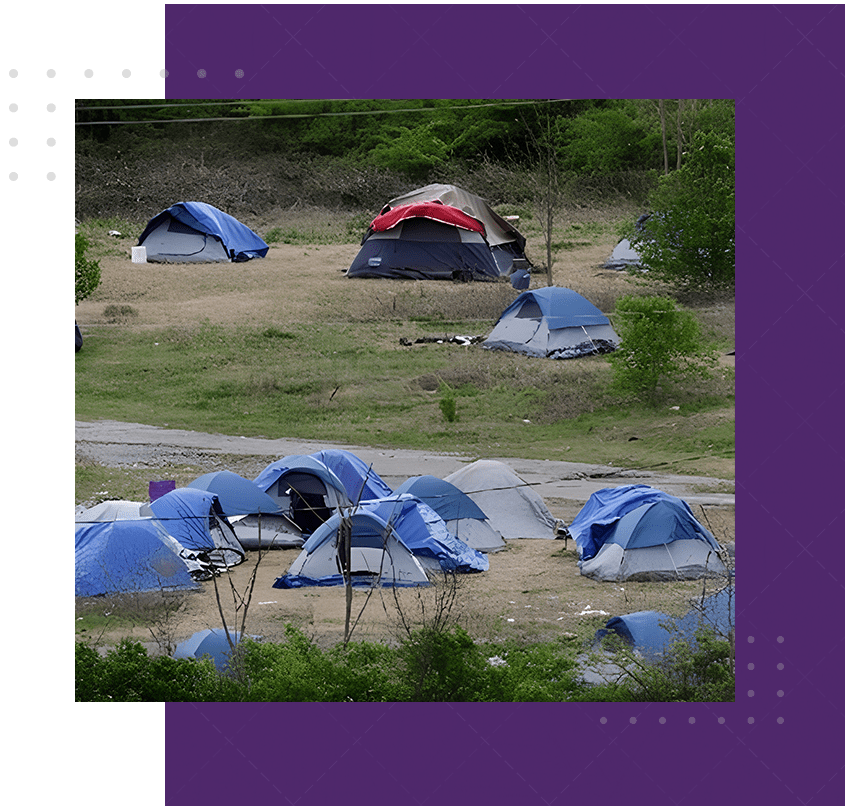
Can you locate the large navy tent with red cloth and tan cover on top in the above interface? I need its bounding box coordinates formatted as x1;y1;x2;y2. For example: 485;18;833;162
347;183;530;281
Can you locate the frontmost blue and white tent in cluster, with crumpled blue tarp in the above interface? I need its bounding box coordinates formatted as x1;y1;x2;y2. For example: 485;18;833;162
273;495;489;588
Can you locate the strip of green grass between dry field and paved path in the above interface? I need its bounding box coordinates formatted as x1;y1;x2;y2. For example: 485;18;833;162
75;316;734;477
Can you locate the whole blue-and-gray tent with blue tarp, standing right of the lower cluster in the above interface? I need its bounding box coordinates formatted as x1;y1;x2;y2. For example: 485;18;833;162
569;484;726;582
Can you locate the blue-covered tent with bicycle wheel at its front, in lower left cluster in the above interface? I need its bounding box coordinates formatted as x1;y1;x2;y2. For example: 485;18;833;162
148;487;246;568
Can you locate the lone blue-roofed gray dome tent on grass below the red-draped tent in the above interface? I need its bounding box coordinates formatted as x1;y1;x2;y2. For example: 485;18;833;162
482;287;619;360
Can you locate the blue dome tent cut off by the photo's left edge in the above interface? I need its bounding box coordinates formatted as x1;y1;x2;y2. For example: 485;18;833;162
74;518;198;596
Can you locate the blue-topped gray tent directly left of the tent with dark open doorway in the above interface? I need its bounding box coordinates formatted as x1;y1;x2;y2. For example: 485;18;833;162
189;470;304;550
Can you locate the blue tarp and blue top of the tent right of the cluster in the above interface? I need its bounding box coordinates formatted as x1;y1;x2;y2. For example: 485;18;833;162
569;484;719;560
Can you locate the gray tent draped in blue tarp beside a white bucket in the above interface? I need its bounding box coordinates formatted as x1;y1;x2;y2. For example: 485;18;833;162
139;202;269;262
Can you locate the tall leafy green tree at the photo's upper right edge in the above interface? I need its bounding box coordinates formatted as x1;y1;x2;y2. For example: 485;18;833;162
631;132;735;289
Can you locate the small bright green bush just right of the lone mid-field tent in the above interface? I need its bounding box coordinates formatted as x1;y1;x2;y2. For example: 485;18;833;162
607;295;711;402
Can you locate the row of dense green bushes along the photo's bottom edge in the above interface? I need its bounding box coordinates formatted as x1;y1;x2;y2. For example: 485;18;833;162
75;627;734;703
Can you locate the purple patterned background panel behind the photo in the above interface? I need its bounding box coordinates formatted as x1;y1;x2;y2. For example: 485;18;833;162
148;4;845;806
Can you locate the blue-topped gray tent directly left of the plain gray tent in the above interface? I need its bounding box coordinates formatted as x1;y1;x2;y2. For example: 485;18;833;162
394;475;506;553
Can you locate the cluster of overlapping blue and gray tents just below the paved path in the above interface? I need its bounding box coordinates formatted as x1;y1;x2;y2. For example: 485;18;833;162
75;449;557;596
